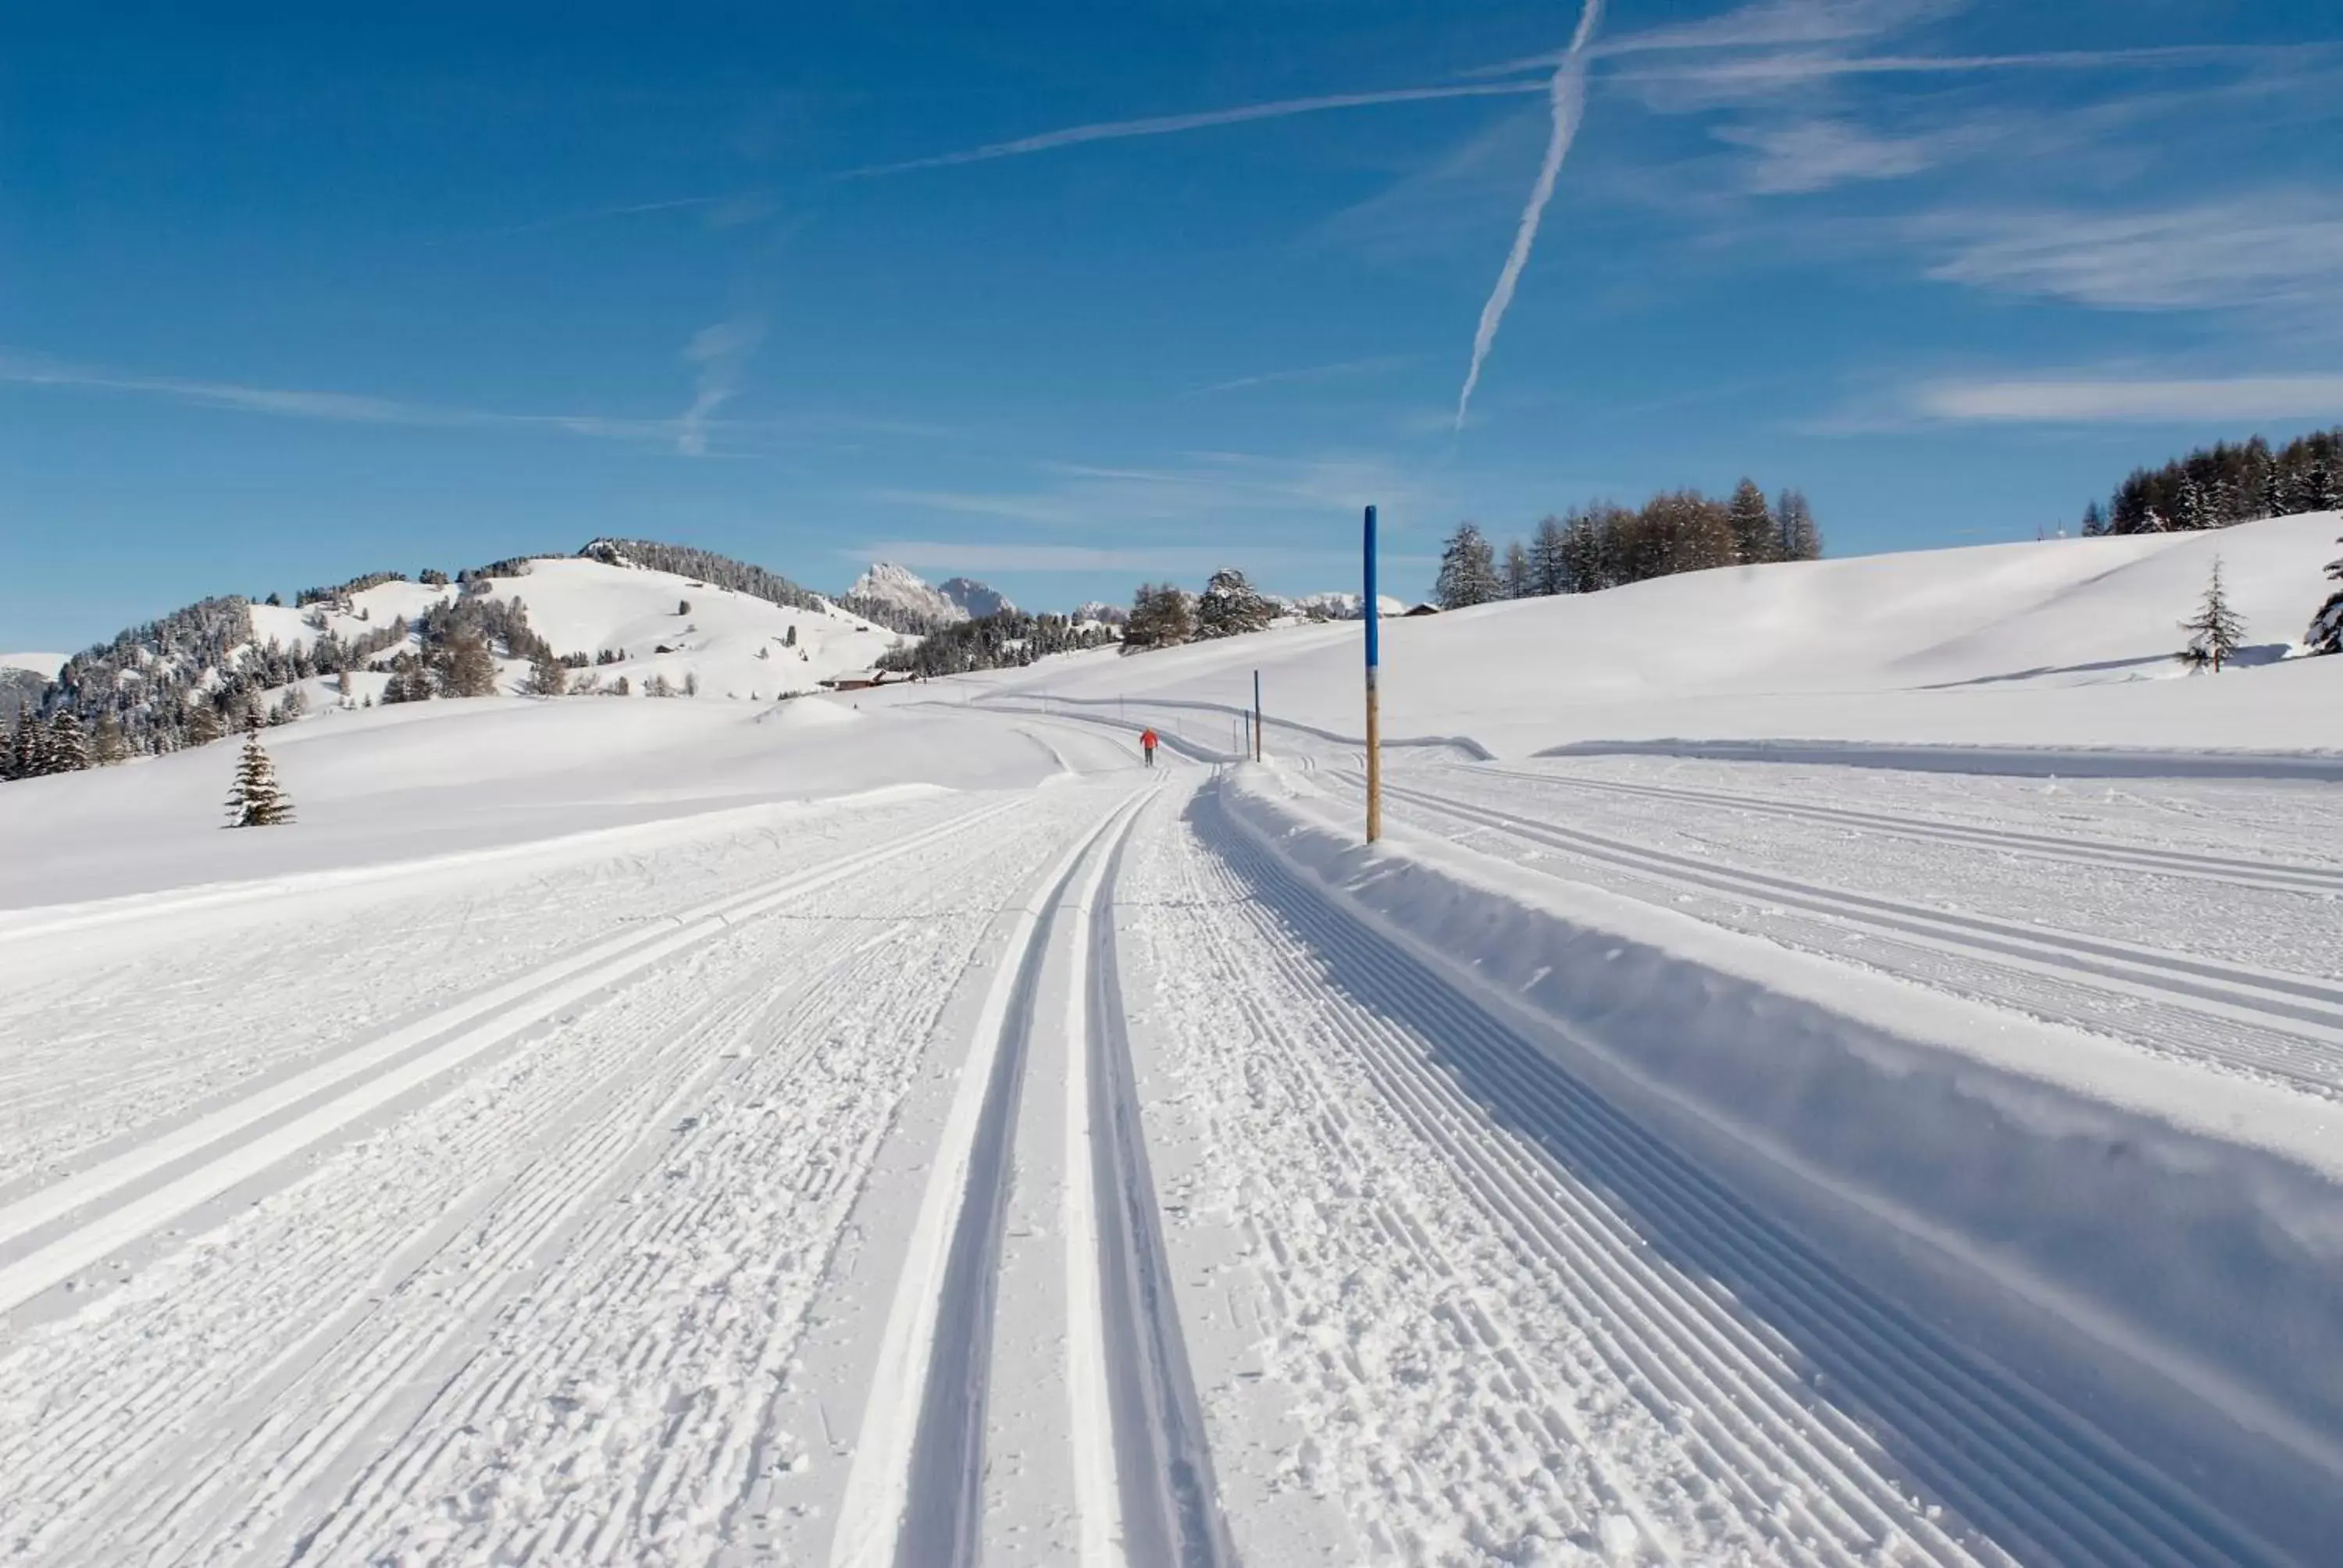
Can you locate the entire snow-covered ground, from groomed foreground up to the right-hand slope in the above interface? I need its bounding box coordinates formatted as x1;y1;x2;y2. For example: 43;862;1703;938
0;518;2343;1568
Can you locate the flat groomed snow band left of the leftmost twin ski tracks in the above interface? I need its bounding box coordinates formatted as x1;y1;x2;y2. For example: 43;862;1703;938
0;802;998;1203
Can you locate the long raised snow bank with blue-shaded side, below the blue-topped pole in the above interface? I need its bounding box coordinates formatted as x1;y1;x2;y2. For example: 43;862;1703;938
1202;768;2343;1540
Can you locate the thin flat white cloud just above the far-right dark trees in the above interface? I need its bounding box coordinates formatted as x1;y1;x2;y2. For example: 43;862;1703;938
1912;375;2343;424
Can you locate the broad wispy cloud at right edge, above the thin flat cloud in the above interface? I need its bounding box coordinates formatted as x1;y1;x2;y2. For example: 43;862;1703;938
1910;194;2343;309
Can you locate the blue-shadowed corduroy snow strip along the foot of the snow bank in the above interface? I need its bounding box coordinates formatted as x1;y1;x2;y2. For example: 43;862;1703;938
1221;787;2282;1568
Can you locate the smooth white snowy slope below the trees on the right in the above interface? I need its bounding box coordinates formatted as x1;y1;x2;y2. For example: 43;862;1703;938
977;513;2343;754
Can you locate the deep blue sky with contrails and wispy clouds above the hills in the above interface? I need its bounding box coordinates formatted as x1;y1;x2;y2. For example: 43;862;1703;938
0;0;2343;647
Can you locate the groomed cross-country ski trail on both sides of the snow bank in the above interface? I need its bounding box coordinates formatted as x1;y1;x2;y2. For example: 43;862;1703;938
0;726;2343;1568
